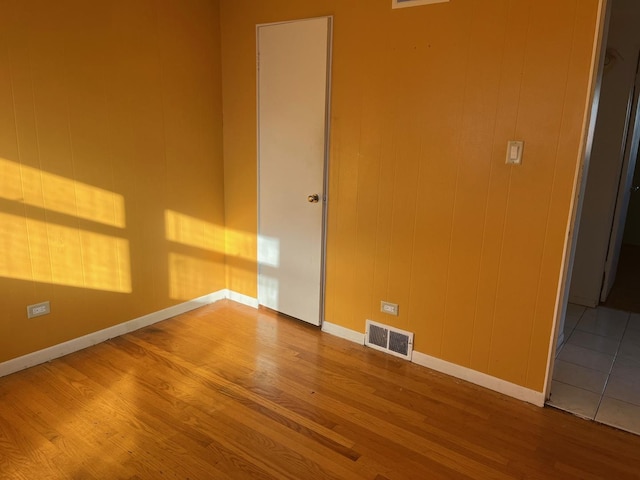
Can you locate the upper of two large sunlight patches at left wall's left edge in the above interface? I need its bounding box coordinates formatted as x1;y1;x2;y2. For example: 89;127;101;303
0;158;126;228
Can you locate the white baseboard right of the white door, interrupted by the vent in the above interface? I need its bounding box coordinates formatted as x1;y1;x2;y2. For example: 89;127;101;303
322;322;544;407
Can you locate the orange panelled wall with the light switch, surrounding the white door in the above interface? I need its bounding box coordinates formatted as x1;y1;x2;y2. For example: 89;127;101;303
221;0;600;391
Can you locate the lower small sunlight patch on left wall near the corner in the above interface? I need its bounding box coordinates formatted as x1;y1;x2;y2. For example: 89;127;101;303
169;253;220;300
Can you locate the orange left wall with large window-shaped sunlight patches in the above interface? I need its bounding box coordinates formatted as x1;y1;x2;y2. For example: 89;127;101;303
0;0;225;362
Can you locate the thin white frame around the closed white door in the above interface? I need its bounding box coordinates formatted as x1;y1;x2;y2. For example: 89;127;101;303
256;15;333;326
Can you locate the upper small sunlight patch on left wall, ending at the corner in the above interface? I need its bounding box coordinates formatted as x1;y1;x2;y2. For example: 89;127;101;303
164;210;224;253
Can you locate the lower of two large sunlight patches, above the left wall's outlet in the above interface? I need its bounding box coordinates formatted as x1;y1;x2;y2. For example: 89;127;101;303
0;212;131;293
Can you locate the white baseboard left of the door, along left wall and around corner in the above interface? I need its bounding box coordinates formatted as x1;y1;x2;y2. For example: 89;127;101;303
0;289;258;377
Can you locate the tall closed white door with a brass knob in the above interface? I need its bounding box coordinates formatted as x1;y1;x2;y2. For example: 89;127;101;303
257;17;331;325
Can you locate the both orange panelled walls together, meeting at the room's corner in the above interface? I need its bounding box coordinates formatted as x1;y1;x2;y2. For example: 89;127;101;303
0;0;599;400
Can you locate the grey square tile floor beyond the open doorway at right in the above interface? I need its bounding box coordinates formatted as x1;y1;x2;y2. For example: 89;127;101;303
548;304;640;435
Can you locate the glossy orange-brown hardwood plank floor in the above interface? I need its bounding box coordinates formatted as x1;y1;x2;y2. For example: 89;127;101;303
0;301;640;480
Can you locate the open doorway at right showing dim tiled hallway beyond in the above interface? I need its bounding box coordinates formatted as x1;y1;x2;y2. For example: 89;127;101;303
548;0;640;434
